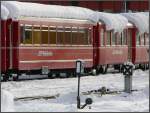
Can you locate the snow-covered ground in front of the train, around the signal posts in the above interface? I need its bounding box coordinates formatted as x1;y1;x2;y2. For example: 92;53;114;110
1;70;149;112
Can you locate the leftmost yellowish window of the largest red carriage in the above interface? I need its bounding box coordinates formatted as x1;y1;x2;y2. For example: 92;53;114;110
23;26;32;44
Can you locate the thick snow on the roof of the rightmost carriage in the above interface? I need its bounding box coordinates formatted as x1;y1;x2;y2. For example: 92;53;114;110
121;12;149;34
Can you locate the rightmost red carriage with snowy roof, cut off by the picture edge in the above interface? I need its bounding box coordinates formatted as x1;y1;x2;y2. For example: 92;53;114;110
122;12;149;70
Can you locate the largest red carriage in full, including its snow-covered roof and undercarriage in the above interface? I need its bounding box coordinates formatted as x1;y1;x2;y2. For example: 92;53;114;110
3;1;96;80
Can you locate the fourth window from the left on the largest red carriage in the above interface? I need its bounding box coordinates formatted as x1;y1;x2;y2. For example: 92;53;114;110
49;26;57;44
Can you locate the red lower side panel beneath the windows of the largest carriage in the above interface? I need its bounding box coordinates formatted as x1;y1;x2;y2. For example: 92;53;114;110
19;46;93;70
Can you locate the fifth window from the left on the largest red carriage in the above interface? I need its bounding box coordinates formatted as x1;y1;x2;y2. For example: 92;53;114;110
57;26;64;44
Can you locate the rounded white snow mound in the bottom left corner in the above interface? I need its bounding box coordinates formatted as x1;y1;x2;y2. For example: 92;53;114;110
1;90;14;112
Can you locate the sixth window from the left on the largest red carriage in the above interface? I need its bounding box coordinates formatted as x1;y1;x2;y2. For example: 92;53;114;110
64;27;72;44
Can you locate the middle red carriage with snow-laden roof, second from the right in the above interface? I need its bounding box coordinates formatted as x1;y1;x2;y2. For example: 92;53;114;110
94;12;128;73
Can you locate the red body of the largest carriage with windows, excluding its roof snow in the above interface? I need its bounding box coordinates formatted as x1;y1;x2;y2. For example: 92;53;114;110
13;18;93;78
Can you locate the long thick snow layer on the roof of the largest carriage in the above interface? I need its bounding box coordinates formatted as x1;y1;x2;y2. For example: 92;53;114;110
2;1;97;22
